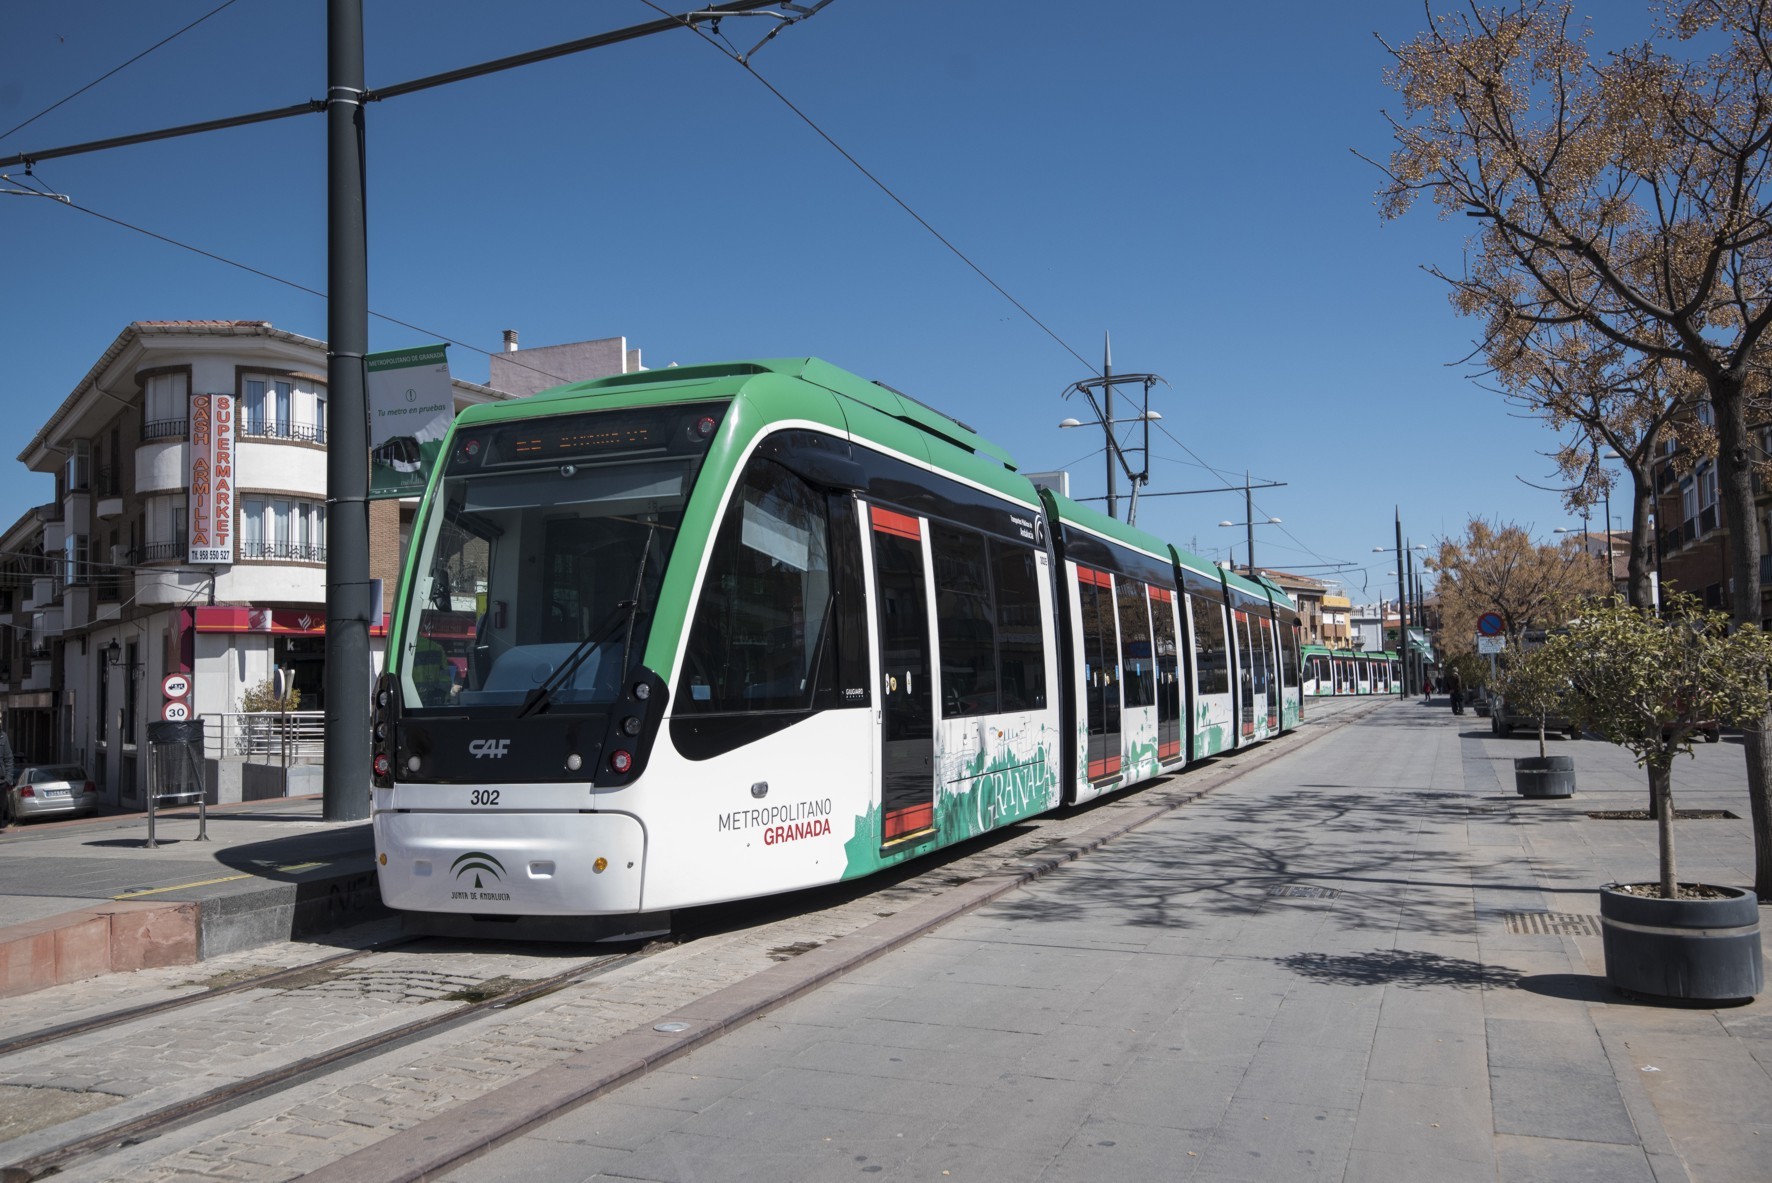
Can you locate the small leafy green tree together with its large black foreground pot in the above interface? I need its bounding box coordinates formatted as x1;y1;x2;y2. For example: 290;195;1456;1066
1540;595;1772;1001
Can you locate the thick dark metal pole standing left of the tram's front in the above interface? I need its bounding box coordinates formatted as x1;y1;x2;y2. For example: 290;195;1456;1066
323;0;370;822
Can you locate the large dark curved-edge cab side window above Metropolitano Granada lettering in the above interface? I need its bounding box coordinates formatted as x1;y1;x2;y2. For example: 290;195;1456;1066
677;457;838;714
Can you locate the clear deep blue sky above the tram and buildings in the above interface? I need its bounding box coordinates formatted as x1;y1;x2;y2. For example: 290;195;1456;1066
0;0;1620;599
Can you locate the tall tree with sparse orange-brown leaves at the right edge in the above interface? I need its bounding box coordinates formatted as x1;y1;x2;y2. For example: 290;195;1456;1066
1380;0;1772;900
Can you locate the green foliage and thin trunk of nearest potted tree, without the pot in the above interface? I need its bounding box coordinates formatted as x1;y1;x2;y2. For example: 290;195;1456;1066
1538;595;1772;900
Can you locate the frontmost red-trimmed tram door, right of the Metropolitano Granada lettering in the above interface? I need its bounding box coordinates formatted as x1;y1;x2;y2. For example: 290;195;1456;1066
870;505;936;847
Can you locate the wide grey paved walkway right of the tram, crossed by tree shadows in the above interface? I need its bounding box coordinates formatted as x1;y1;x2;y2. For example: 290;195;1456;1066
432;700;1772;1183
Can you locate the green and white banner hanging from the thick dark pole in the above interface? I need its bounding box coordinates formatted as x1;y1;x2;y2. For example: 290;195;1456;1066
363;345;455;498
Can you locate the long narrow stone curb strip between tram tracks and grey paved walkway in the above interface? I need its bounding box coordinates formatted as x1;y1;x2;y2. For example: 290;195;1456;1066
301;698;1391;1183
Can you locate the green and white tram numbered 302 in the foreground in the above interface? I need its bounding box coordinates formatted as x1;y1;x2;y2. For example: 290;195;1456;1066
372;360;1302;919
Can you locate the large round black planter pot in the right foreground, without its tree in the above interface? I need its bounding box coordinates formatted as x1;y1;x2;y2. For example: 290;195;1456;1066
1600;885;1765;1002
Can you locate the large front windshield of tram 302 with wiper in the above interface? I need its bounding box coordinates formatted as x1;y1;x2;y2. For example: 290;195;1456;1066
399;404;725;714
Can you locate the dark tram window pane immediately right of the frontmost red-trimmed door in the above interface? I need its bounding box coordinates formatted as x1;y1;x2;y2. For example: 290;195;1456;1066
929;522;998;719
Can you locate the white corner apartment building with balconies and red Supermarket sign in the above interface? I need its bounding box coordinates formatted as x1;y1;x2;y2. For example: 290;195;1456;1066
0;321;507;806
